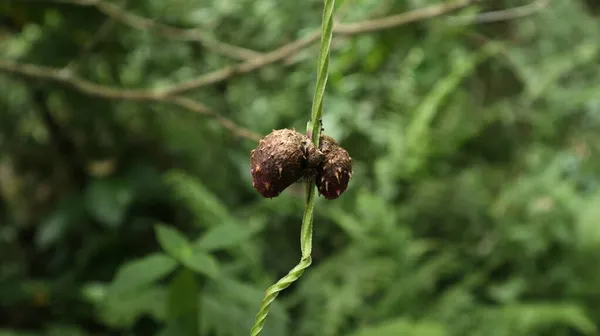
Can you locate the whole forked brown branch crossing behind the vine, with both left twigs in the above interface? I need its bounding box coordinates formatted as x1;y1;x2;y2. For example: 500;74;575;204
0;0;481;141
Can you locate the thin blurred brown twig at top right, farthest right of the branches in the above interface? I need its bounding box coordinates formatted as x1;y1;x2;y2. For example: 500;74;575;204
450;0;550;24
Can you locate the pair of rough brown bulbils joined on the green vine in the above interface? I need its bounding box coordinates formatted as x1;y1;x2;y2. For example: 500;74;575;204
250;128;352;199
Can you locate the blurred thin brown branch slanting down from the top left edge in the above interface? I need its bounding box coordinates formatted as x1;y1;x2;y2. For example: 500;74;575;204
28;0;261;60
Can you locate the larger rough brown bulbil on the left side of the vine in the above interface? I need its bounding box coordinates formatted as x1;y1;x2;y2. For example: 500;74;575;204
250;129;324;198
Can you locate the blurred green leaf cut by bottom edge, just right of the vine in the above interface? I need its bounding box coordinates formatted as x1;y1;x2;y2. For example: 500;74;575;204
351;318;448;336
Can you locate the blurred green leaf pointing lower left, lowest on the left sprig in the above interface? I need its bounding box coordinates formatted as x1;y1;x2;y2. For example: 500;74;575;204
109;253;177;294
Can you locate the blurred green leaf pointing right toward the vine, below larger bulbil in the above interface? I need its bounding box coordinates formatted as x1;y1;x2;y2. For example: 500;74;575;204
195;220;262;251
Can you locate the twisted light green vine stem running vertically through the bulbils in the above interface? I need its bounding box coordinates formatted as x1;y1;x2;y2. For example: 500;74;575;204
250;0;335;336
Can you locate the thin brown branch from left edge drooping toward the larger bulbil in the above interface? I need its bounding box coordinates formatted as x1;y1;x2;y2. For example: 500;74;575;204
0;60;260;141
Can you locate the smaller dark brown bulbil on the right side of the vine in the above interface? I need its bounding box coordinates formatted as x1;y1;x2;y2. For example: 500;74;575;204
315;134;352;200
